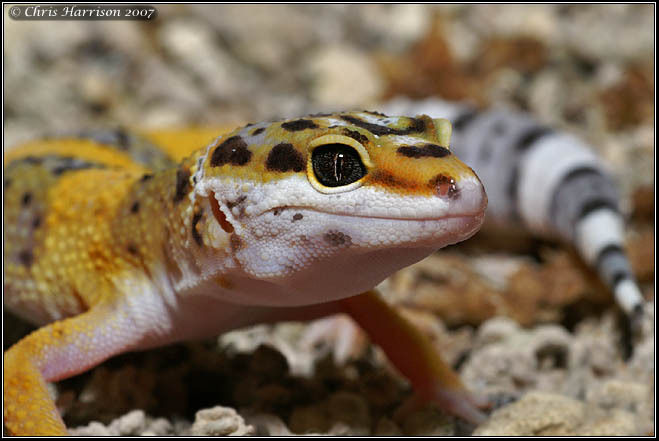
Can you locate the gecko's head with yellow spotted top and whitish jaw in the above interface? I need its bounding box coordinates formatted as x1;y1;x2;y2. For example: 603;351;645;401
196;112;487;306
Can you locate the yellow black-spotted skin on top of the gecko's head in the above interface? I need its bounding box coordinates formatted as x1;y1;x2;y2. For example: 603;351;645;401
205;112;473;196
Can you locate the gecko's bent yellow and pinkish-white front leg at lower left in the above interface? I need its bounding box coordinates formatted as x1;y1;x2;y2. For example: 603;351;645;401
3;288;173;435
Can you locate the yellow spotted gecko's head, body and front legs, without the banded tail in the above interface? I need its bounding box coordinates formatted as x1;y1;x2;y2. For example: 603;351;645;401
3;112;487;435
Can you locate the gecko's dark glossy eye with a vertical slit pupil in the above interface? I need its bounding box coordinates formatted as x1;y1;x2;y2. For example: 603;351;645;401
311;144;366;187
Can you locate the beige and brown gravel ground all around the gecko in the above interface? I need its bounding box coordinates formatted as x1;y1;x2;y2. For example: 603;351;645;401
3;5;655;436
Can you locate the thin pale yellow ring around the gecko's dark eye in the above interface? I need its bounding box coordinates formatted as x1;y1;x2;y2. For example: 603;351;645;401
307;134;373;194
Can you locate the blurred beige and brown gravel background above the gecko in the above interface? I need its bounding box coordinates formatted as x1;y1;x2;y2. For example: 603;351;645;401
3;4;654;189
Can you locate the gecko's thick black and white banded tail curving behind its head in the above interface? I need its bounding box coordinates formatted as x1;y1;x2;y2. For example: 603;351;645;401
386;99;643;326
